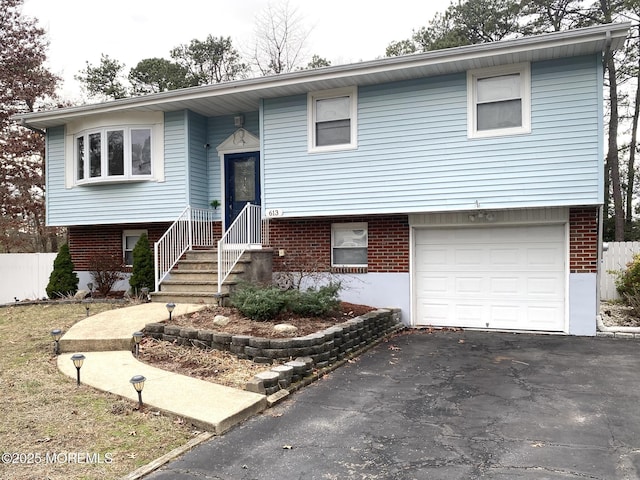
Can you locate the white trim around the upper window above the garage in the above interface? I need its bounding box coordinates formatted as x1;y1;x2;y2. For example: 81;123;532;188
467;63;531;138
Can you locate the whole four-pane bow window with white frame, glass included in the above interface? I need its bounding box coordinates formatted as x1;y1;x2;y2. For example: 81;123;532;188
74;126;152;184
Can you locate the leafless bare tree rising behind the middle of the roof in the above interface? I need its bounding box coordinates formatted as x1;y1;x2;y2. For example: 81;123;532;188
252;0;310;75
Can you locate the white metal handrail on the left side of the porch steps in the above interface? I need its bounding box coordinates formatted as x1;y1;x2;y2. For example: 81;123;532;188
153;205;217;292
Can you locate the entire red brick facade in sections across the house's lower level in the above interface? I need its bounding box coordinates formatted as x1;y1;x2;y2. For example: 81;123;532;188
69;207;598;273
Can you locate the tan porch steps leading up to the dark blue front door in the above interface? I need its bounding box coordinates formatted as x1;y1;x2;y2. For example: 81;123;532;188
151;250;249;304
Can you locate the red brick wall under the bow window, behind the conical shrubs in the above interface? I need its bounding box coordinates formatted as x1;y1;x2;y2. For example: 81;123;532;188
69;222;222;271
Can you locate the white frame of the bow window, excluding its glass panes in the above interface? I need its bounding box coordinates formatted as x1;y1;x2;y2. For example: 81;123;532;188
73;125;155;185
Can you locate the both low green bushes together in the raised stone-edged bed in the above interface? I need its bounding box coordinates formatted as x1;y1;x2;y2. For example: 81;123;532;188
231;283;341;321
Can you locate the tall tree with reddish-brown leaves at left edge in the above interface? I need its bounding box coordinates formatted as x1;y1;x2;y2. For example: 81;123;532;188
0;0;58;252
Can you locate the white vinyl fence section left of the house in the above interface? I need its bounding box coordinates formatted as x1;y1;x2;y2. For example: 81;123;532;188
0;253;57;304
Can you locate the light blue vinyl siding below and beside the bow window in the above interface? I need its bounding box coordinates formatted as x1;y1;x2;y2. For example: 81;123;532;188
46;112;188;226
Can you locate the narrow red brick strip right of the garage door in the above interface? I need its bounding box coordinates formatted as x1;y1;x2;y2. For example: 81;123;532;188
569;207;598;273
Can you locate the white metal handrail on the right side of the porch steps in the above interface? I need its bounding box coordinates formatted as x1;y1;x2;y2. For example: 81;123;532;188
218;203;269;292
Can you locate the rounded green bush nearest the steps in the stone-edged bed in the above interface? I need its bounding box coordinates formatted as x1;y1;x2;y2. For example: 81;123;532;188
230;285;286;322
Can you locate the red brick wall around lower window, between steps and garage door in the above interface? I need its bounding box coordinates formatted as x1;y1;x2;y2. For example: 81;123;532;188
269;215;409;273
